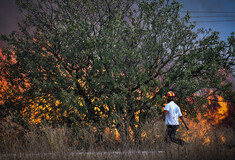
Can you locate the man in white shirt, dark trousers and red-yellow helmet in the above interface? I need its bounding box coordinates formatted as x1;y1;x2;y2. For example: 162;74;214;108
154;91;189;145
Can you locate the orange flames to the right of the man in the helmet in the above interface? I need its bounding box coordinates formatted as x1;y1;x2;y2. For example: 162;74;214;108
183;95;229;145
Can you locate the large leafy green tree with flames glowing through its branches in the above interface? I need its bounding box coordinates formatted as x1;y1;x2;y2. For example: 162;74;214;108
2;0;234;140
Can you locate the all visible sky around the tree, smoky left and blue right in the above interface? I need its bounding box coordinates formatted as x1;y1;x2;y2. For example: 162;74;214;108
0;0;235;88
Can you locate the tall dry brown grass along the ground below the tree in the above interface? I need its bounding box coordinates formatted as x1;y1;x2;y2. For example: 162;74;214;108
0;118;235;160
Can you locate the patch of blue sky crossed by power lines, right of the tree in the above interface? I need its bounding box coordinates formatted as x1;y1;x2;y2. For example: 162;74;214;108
178;0;235;40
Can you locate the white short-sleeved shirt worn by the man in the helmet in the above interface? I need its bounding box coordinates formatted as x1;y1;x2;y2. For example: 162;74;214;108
164;101;182;125
